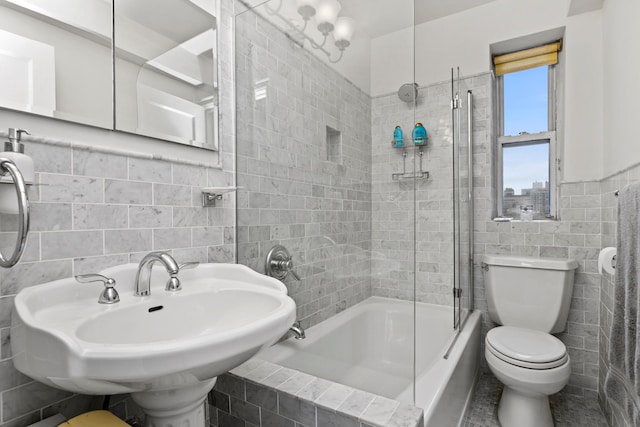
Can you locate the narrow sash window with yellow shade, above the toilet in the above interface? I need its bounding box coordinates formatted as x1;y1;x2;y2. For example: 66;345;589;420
494;42;561;220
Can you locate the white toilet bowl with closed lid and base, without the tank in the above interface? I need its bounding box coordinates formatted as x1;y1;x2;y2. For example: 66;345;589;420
485;326;571;427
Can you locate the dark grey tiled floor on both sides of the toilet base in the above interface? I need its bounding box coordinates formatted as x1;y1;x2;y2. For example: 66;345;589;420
464;373;607;427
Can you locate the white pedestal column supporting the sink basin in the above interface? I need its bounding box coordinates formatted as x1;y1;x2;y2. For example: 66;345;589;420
131;378;216;427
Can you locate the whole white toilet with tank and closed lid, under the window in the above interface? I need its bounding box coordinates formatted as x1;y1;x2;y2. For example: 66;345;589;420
482;255;578;427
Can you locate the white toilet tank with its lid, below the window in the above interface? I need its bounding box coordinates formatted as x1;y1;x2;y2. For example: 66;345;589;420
482;255;578;333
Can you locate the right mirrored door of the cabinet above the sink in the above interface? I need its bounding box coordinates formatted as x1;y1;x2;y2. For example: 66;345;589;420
114;0;218;149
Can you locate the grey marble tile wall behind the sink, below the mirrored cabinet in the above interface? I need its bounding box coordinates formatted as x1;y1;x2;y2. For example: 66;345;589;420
0;138;235;426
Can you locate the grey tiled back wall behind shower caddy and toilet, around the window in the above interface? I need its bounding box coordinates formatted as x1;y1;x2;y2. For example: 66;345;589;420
372;70;606;399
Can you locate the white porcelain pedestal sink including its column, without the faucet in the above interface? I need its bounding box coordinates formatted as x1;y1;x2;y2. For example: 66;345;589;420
11;264;295;427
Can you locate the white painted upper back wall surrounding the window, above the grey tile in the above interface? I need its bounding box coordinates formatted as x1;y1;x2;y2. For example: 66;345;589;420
371;0;604;181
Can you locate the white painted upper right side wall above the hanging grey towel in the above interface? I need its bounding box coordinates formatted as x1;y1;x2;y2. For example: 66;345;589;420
602;0;640;176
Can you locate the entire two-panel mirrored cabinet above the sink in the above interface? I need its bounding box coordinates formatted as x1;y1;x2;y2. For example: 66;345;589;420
0;0;218;150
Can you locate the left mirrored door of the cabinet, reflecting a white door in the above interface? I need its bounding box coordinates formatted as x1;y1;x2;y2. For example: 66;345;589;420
0;0;113;129
